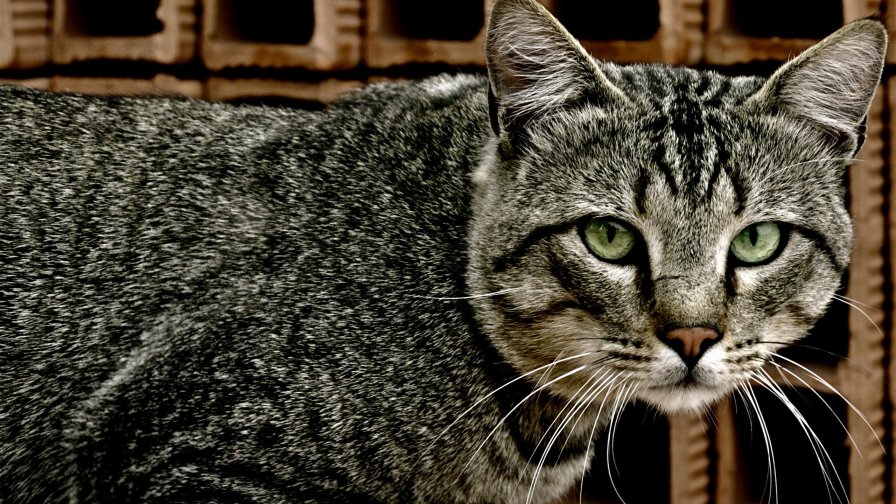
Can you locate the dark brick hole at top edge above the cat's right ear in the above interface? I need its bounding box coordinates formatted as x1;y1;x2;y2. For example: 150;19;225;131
728;0;843;39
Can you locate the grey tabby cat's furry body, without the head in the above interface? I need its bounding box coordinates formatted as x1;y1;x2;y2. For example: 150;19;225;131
0;76;582;502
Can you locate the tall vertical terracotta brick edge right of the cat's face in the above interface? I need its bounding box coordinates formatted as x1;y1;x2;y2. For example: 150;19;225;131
837;83;887;504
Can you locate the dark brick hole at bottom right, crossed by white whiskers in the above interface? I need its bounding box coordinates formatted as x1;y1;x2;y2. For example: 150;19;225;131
735;386;849;502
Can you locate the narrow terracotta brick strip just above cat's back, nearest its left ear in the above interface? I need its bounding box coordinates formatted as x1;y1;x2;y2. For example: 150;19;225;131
207;77;363;103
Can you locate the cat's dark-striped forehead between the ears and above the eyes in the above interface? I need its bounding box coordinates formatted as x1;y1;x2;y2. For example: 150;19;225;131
518;64;840;236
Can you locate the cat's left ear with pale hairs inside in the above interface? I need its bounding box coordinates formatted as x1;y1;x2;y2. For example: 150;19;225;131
486;0;628;137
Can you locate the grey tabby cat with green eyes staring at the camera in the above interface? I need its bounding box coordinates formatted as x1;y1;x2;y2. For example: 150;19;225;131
0;0;887;503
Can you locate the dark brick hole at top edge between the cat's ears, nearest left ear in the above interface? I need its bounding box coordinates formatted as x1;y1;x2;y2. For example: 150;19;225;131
551;0;660;40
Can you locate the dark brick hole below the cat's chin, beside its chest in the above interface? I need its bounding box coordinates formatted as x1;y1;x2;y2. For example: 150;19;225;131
569;403;669;504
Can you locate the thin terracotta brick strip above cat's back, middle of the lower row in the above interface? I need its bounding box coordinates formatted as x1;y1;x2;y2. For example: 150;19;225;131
50;75;204;98
